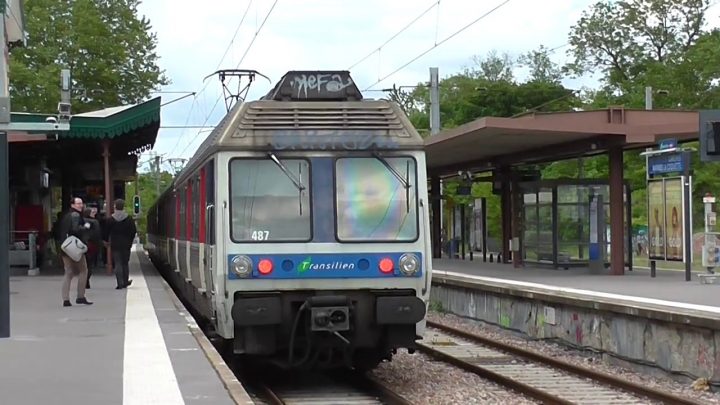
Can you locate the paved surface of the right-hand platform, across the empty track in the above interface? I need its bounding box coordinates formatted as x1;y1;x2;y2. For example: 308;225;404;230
433;258;720;307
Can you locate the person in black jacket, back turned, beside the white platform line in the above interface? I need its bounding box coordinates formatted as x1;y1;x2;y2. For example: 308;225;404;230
104;199;137;290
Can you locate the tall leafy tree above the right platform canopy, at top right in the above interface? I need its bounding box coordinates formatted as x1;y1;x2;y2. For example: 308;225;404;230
566;0;720;101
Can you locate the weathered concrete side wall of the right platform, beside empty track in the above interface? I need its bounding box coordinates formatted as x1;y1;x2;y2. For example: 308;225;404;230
431;282;720;381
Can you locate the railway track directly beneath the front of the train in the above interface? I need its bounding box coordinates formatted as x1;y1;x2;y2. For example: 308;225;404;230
245;373;412;405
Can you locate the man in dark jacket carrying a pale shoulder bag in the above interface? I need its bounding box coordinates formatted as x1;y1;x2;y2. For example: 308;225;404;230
58;197;92;307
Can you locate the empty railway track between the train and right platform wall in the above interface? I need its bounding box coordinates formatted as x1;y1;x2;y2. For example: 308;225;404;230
420;321;699;405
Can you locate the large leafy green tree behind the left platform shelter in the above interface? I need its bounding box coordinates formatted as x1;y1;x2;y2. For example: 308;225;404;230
9;0;169;113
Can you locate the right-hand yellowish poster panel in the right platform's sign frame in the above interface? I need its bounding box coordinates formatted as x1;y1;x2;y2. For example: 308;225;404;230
665;178;685;261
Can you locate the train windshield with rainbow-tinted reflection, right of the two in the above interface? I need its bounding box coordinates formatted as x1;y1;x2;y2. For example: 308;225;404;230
335;156;418;242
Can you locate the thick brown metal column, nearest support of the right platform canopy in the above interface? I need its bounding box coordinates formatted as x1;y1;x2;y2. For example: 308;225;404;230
609;147;625;275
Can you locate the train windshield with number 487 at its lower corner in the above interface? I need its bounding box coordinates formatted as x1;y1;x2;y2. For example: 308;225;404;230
230;158;312;242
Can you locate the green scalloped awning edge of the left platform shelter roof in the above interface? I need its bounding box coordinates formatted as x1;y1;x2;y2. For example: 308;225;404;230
10;97;160;140
